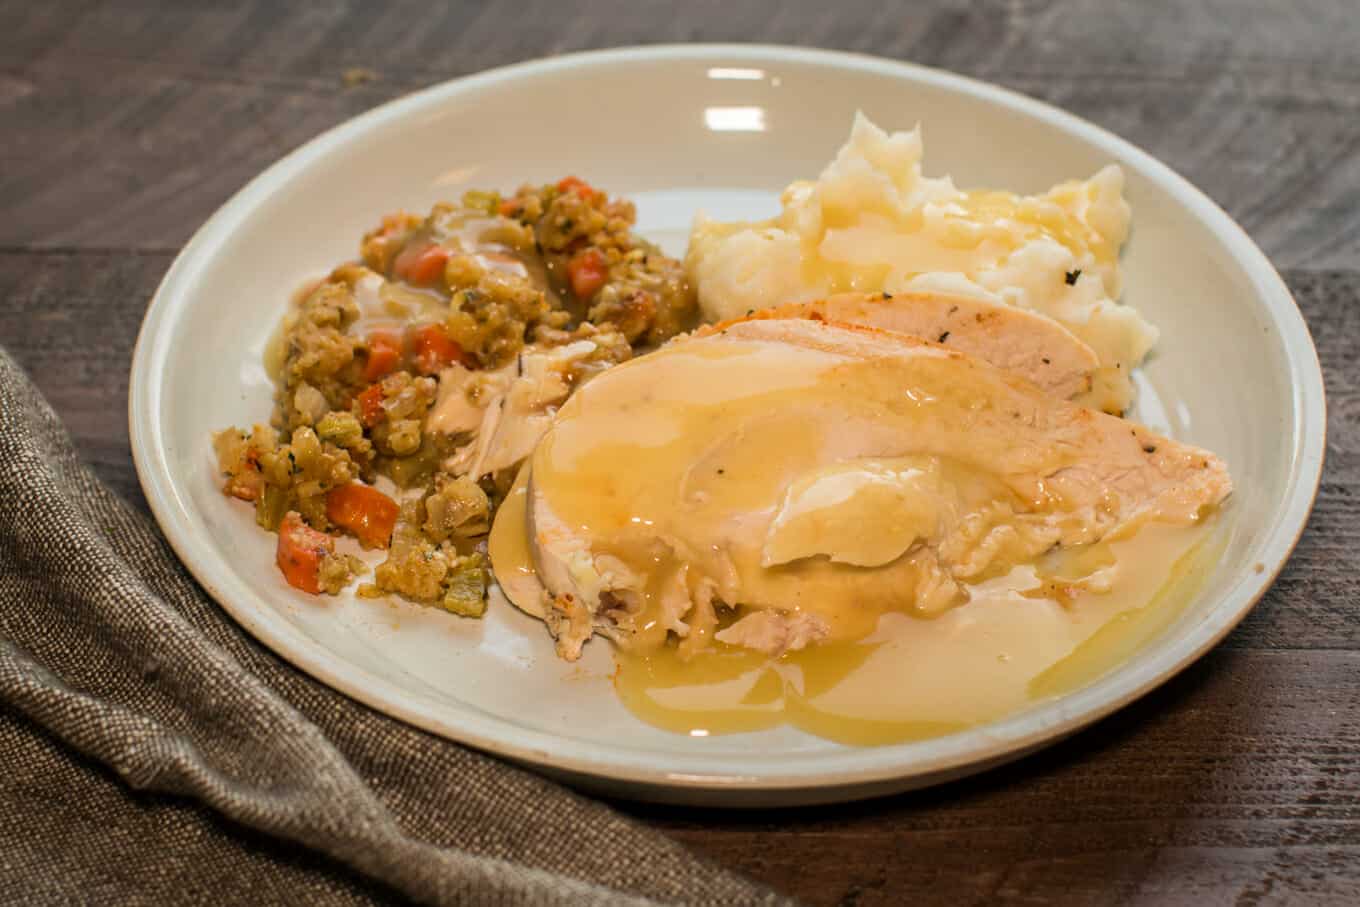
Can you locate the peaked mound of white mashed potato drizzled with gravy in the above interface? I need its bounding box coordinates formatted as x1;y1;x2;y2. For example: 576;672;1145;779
685;114;1157;413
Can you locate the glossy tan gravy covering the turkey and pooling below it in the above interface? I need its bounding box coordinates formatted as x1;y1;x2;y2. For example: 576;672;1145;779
490;328;1234;745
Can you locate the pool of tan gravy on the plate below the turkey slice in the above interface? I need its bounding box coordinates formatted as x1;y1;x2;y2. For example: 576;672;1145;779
615;519;1221;745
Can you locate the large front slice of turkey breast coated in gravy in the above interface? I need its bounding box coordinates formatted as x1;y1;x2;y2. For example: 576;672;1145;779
491;318;1232;658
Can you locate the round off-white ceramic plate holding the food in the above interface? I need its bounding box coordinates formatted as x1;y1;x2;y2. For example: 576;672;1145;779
129;46;1325;805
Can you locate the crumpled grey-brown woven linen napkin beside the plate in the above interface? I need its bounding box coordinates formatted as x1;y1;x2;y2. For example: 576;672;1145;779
0;349;781;904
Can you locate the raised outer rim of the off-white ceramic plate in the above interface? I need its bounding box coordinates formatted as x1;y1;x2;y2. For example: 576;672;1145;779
128;44;1326;797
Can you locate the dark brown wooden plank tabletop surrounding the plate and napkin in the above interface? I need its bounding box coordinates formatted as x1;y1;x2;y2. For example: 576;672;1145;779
0;0;1360;904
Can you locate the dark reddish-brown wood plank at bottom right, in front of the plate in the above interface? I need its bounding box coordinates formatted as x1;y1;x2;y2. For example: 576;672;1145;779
622;649;1360;907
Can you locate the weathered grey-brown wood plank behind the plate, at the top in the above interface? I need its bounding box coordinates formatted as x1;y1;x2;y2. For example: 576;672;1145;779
0;0;1360;268
